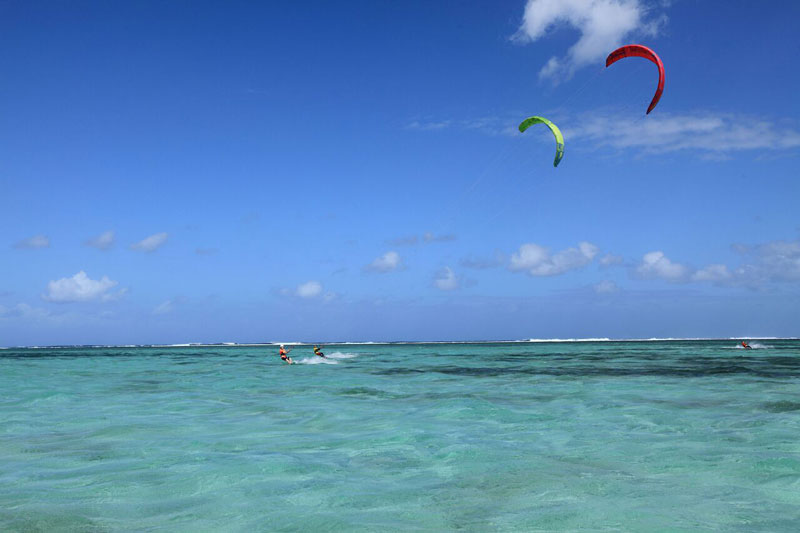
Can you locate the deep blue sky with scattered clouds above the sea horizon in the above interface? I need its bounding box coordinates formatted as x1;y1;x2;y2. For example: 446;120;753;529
0;0;800;346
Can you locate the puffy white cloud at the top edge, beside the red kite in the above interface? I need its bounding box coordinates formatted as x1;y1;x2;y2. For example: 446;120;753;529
513;0;666;82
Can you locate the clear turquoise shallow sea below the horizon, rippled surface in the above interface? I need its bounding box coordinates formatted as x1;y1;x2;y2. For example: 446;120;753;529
0;340;800;531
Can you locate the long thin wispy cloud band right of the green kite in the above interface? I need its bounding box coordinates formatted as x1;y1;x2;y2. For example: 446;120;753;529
564;112;800;156
